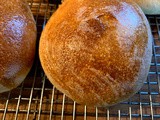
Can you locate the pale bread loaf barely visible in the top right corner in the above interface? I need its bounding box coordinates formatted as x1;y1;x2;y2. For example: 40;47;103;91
133;0;160;14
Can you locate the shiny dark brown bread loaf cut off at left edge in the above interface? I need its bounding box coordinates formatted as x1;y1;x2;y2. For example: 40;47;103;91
0;0;36;93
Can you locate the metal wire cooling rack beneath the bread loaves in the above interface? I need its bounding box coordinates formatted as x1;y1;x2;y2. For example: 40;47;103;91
0;0;160;120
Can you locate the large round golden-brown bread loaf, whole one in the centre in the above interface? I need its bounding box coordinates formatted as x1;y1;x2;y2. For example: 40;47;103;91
39;0;152;107
